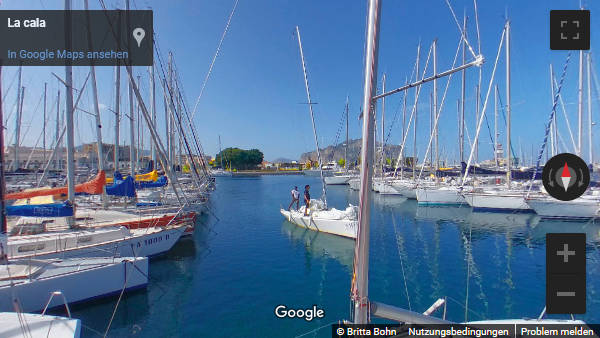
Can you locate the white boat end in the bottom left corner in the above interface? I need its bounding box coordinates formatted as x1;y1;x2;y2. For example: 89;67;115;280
0;312;81;338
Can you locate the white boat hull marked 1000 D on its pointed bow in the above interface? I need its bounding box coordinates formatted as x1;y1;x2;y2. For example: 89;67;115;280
8;227;185;259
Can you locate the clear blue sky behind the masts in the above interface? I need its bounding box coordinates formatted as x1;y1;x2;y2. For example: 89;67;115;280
0;0;600;164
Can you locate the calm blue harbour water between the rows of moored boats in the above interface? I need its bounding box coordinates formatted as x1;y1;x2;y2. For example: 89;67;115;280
68;176;600;337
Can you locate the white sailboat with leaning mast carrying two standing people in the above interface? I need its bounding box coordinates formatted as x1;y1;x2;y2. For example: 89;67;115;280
280;26;358;238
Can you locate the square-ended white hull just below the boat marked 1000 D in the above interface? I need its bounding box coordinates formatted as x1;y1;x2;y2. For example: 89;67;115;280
0;257;148;312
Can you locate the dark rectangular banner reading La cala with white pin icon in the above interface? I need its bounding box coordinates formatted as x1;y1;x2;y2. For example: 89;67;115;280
0;10;154;66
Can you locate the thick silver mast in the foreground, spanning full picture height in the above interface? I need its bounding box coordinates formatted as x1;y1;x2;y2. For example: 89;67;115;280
352;0;381;324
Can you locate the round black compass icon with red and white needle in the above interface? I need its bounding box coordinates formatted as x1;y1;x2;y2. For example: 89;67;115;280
542;153;590;201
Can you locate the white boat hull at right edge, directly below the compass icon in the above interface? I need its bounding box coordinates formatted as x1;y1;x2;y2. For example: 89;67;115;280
527;198;600;219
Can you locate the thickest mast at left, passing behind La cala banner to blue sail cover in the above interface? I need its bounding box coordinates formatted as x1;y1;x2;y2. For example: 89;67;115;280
65;0;75;228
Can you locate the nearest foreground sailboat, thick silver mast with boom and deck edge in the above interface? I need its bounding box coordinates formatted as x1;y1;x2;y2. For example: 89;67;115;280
346;0;585;325
